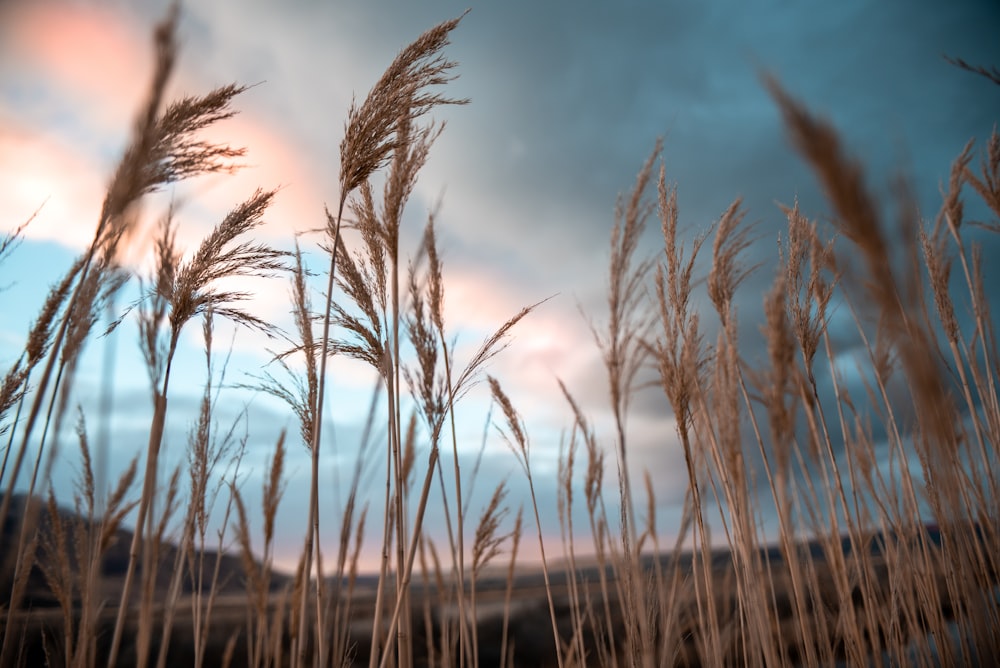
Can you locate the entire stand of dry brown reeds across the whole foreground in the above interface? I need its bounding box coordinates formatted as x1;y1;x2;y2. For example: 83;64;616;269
0;9;1000;668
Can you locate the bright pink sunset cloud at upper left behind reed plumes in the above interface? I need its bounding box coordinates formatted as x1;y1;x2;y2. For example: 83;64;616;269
0;3;334;264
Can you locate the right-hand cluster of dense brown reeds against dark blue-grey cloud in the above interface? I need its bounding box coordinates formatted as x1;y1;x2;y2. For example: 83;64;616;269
540;70;1000;666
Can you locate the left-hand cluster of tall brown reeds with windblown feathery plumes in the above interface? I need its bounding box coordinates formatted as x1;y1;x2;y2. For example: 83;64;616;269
0;8;533;666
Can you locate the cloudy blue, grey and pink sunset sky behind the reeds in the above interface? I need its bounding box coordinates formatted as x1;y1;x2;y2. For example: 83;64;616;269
0;0;1000;566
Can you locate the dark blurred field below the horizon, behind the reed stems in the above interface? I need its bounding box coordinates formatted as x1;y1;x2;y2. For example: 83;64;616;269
3;497;1000;667
